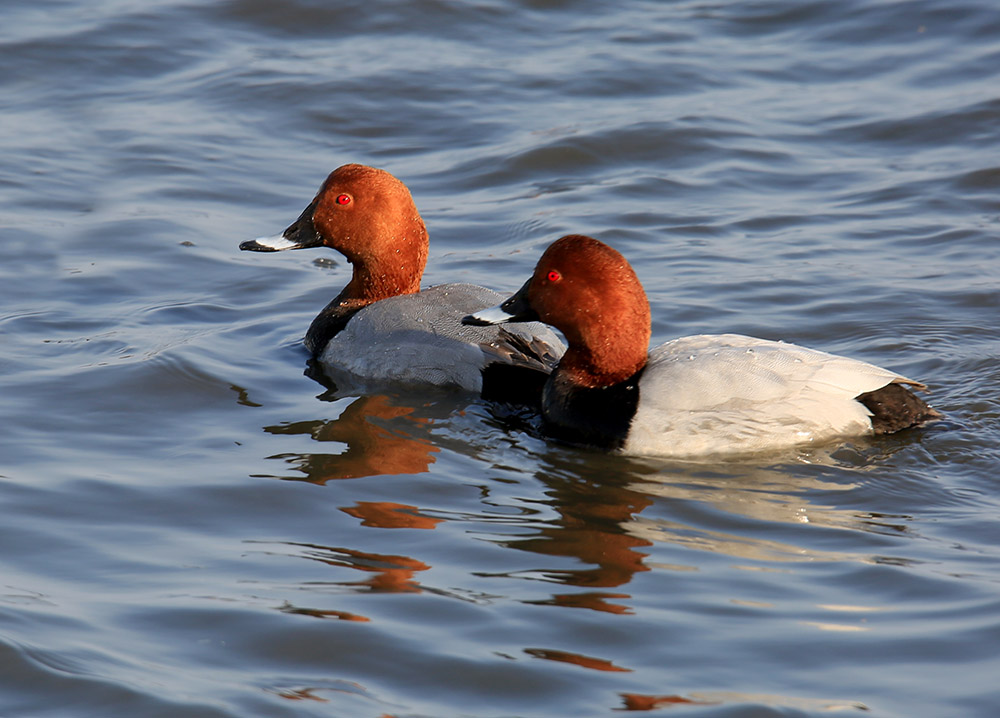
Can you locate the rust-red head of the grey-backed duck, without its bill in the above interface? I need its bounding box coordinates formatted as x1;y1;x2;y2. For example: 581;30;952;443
310;164;428;300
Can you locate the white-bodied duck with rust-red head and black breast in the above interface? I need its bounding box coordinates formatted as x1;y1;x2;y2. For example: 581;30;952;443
462;235;941;459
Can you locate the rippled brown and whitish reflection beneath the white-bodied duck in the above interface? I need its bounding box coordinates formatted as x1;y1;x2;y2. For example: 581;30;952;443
476;448;909;613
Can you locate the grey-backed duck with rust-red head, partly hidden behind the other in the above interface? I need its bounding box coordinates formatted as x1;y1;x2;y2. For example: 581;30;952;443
240;164;565;403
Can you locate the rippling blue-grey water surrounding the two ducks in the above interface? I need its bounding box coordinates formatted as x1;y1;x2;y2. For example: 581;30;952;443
0;0;1000;718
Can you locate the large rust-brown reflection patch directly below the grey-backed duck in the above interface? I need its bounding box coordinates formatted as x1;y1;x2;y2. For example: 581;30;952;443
264;394;439;484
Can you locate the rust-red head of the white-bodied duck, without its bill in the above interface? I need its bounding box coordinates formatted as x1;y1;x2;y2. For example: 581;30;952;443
528;235;651;387
